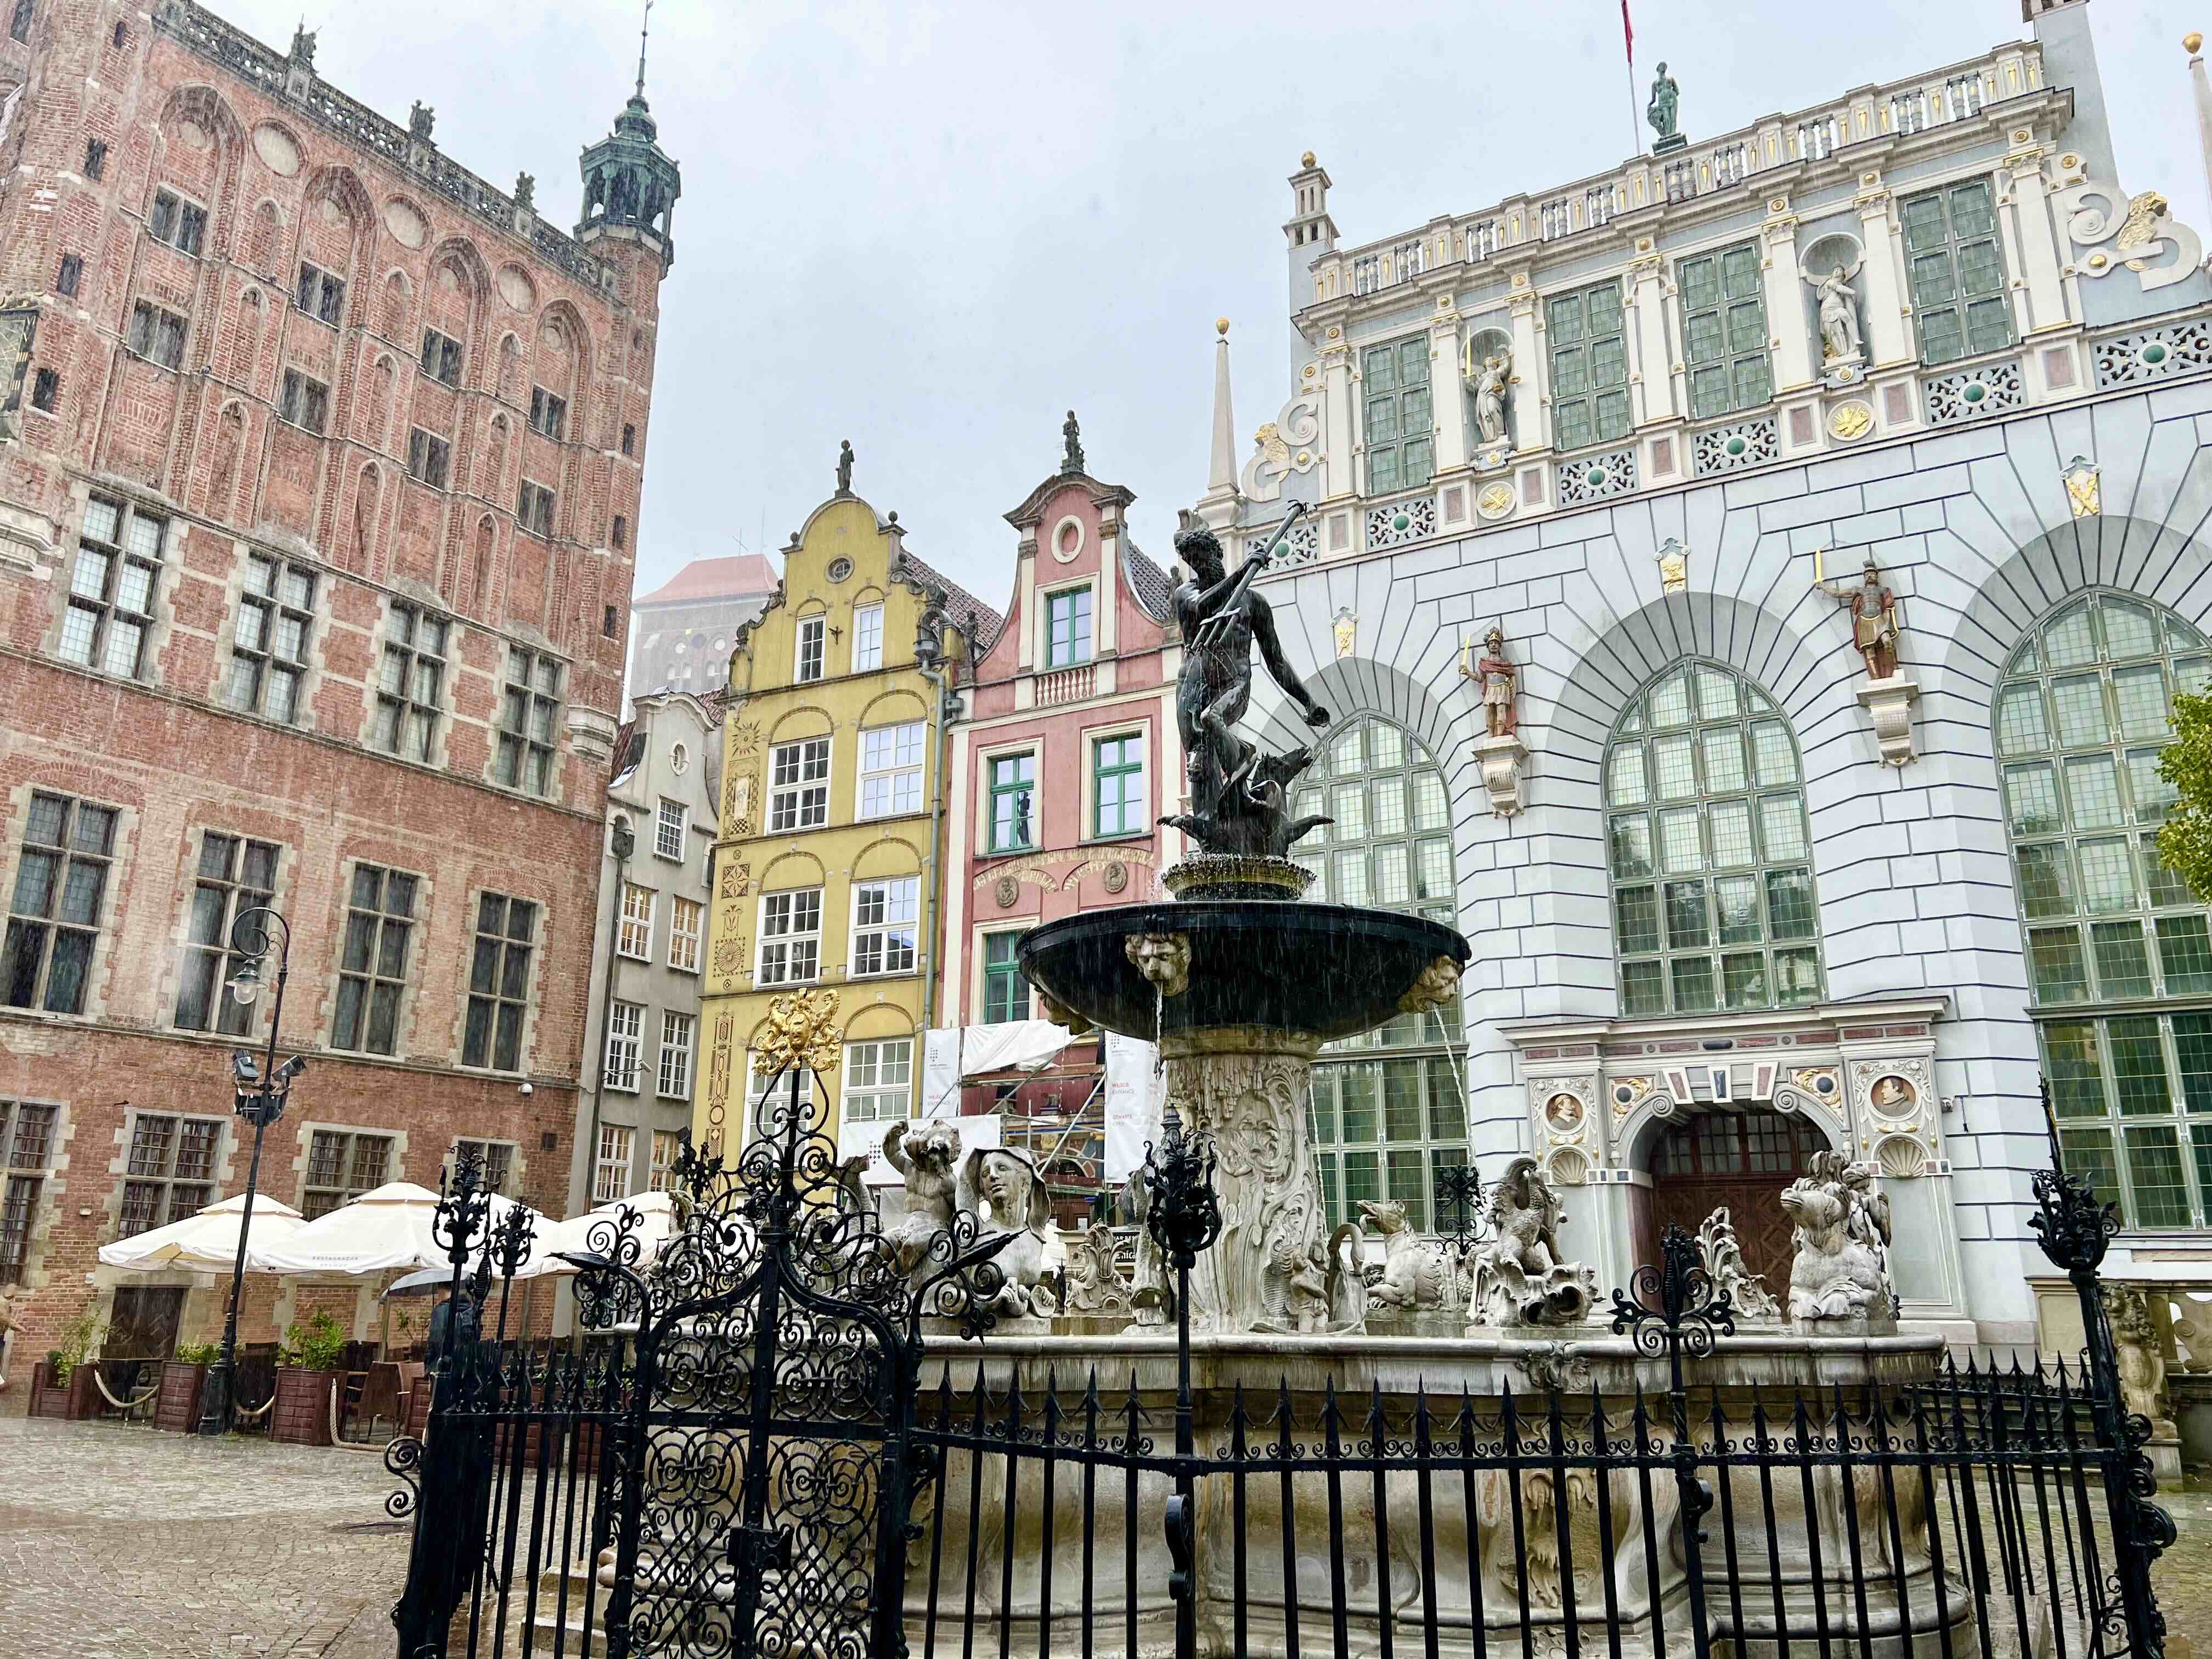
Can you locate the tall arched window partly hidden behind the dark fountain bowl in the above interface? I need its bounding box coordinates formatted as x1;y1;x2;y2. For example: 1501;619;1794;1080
1294;716;1466;1230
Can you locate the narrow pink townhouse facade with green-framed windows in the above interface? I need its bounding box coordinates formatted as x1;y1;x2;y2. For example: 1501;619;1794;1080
938;431;1181;1053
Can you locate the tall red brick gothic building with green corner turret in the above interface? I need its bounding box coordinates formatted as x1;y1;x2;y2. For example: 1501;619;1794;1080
0;0;679;1404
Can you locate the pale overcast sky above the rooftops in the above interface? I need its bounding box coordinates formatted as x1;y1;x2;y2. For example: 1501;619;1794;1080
212;0;2212;606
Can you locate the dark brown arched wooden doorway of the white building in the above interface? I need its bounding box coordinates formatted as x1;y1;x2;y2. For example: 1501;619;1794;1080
1637;1108;1827;1303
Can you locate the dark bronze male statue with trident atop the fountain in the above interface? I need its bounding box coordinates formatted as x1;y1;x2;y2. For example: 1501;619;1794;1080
1161;502;1329;858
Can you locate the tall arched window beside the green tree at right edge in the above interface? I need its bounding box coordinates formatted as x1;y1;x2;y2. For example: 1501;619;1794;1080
1995;593;2212;1228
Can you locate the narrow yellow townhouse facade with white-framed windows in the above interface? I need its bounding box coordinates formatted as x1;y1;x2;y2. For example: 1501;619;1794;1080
692;473;1002;1155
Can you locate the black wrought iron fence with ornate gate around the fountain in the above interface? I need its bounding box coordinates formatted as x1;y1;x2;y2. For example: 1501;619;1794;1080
390;1066;2172;1659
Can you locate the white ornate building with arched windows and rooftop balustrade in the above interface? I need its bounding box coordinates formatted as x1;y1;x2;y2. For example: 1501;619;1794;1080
1199;0;2212;1340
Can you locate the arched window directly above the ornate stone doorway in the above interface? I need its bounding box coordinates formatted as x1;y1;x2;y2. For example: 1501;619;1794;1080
1606;662;1820;1015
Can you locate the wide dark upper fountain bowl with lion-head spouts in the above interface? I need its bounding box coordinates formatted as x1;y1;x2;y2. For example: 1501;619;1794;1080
1018;898;1469;1042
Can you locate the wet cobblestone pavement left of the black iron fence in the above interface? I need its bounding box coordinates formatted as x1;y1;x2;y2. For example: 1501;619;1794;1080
0;1418;407;1659
